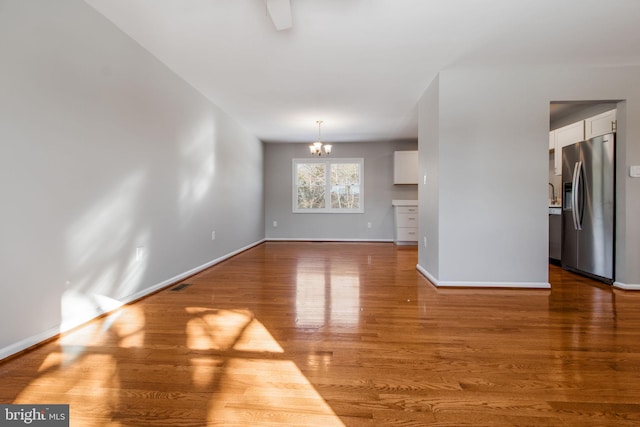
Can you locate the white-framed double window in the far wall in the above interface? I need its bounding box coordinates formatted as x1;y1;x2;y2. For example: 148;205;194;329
293;159;364;213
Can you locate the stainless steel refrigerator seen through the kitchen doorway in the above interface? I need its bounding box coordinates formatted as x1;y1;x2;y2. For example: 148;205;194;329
561;133;615;284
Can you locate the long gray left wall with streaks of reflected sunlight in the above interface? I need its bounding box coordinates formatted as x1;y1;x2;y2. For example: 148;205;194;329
0;0;264;358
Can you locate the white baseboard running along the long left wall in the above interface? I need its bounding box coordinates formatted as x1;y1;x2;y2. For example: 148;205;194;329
0;239;265;361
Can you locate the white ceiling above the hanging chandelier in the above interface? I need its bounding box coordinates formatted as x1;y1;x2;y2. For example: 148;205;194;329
85;0;640;143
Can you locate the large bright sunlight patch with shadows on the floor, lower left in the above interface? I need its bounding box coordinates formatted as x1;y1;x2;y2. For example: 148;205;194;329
13;305;344;427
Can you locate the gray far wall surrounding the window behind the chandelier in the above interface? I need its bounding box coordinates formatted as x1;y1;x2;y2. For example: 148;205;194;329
264;141;418;241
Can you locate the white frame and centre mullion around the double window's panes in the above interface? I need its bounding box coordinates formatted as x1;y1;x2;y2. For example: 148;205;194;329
292;157;364;214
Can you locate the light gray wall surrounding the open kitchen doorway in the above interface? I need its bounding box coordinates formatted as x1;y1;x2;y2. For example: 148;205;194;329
419;67;640;287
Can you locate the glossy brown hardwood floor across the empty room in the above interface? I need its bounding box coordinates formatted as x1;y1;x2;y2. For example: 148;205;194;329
0;242;640;427
